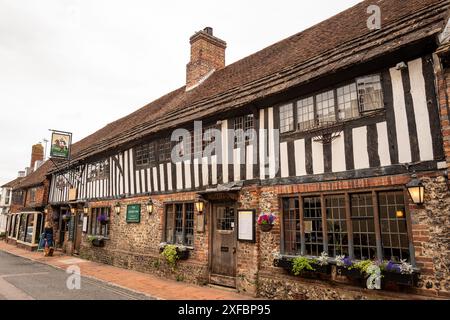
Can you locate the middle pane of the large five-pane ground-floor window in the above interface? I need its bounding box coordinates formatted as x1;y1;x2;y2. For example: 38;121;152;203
325;196;348;257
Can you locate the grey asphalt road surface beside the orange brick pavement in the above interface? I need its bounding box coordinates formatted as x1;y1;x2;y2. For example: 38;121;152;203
0;251;151;300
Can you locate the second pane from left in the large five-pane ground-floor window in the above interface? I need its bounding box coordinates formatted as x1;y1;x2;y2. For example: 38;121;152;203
303;197;323;256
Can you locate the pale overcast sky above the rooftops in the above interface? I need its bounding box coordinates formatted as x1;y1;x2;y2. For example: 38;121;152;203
0;0;360;184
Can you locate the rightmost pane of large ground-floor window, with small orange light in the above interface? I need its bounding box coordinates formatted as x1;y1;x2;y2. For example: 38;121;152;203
378;191;410;262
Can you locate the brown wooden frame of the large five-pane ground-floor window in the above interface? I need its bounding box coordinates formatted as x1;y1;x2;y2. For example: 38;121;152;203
279;186;416;267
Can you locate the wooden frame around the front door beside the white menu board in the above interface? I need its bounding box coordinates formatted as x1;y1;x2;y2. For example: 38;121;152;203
208;199;239;283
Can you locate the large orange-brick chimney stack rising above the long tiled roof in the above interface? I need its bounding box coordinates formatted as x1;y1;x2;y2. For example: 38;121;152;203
186;27;227;91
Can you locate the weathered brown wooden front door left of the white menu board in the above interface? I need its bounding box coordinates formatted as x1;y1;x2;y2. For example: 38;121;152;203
210;204;237;287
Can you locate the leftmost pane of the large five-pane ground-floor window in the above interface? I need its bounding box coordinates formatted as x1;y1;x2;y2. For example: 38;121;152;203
283;198;301;255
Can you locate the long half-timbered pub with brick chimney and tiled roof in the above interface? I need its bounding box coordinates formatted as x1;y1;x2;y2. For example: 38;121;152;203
49;0;450;299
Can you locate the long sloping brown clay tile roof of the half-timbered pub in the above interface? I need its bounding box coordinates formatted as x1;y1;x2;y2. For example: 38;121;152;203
53;0;449;170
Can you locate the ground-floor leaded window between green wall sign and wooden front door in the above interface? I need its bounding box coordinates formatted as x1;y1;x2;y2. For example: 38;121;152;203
165;203;194;247
